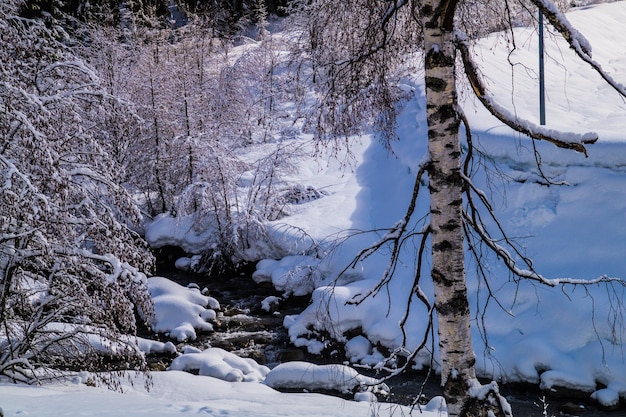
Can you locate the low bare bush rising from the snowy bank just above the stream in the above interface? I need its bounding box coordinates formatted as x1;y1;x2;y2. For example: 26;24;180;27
146;146;324;272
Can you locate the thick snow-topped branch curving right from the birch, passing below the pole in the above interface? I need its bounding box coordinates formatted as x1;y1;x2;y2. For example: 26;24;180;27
456;32;598;156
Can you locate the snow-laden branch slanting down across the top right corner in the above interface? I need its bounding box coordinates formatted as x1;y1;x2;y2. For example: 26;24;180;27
530;0;626;97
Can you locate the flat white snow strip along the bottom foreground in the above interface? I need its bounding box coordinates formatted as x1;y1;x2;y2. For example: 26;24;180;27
0;371;420;417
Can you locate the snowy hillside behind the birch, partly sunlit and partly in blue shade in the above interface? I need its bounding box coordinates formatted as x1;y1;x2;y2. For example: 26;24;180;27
264;2;626;402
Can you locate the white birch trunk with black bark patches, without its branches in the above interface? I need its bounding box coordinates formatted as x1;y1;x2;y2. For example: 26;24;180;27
422;0;476;417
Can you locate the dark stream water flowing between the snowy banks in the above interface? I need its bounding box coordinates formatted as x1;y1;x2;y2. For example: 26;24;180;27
158;270;626;417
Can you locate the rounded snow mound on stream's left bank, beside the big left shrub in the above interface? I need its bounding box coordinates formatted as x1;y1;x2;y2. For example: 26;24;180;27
148;277;220;341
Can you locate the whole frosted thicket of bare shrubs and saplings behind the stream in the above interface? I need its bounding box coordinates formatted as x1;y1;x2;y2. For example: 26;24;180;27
108;25;314;271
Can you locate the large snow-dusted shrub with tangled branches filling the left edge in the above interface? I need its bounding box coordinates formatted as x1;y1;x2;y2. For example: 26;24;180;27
0;1;153;381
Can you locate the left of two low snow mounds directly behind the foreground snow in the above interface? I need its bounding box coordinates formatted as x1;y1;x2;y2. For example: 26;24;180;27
168;348;270;382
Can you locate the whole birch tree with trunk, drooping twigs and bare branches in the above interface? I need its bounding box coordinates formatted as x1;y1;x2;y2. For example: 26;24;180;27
294;0;626;416
